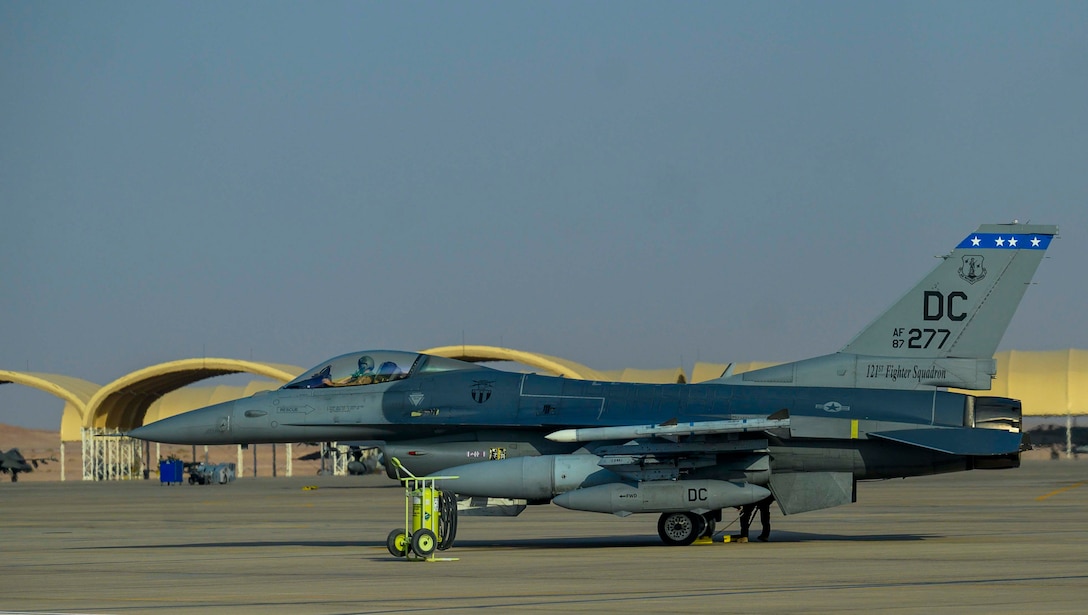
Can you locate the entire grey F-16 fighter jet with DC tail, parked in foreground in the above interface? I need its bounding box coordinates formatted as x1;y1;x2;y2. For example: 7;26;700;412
131;223;1058;544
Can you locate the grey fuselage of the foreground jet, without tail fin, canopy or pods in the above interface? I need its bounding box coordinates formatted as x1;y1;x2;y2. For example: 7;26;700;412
133;366;996;479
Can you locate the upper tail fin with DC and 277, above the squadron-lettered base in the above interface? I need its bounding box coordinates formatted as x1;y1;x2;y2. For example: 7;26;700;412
842;223;1058;359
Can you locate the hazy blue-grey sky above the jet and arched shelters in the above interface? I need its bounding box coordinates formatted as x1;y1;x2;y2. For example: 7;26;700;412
0;1;1088;429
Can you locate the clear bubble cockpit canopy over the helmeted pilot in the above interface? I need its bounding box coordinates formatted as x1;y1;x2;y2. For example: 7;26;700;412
283;350;486;389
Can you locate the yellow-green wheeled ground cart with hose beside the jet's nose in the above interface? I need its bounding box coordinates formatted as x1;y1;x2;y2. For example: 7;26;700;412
385;457;457;562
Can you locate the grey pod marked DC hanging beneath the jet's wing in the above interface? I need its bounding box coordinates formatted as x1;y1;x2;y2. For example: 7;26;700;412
552;480;770;517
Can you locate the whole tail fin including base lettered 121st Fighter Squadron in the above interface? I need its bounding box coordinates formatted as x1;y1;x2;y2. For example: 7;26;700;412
714;223;1058;390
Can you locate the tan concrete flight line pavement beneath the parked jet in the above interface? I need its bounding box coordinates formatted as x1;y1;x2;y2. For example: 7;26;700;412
0;460;1088;614
